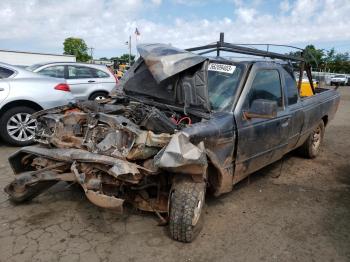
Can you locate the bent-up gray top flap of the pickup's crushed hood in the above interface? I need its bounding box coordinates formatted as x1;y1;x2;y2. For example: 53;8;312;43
137;44;206;83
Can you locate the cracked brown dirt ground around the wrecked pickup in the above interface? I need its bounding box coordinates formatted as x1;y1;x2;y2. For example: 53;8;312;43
0;87;350;262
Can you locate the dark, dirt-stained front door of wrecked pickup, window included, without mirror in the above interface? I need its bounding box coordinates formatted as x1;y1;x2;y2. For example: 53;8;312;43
234;63;291;179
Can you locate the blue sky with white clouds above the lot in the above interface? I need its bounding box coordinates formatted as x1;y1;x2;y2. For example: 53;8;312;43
0;0;350;58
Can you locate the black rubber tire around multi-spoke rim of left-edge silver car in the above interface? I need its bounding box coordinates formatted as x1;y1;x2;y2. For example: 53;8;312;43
0;106;37;146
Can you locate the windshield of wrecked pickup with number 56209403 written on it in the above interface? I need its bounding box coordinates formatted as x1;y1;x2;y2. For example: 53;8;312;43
208;63;242;111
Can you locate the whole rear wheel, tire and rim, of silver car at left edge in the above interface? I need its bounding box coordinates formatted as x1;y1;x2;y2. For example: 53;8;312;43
0;106;36;146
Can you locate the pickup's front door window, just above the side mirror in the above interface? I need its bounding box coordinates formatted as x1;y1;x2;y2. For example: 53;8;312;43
249;69;283;107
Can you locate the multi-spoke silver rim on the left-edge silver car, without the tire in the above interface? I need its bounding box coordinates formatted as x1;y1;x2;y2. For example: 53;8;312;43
6;113;36;142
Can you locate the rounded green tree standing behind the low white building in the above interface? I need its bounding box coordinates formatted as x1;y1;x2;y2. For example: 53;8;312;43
63;37;91;62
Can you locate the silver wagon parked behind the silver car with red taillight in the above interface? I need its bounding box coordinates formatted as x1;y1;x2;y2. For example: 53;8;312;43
27;62;118;100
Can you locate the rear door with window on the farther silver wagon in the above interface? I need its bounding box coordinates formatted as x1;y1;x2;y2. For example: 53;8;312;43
67;65;98;100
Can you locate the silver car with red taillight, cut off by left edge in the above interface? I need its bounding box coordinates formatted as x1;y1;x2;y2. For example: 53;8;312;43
0;63;75;146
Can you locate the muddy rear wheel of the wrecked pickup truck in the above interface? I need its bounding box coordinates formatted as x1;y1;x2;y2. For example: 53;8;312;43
299;120;324;158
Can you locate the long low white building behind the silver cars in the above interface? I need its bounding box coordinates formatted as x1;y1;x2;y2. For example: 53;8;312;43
0;50;76;66
